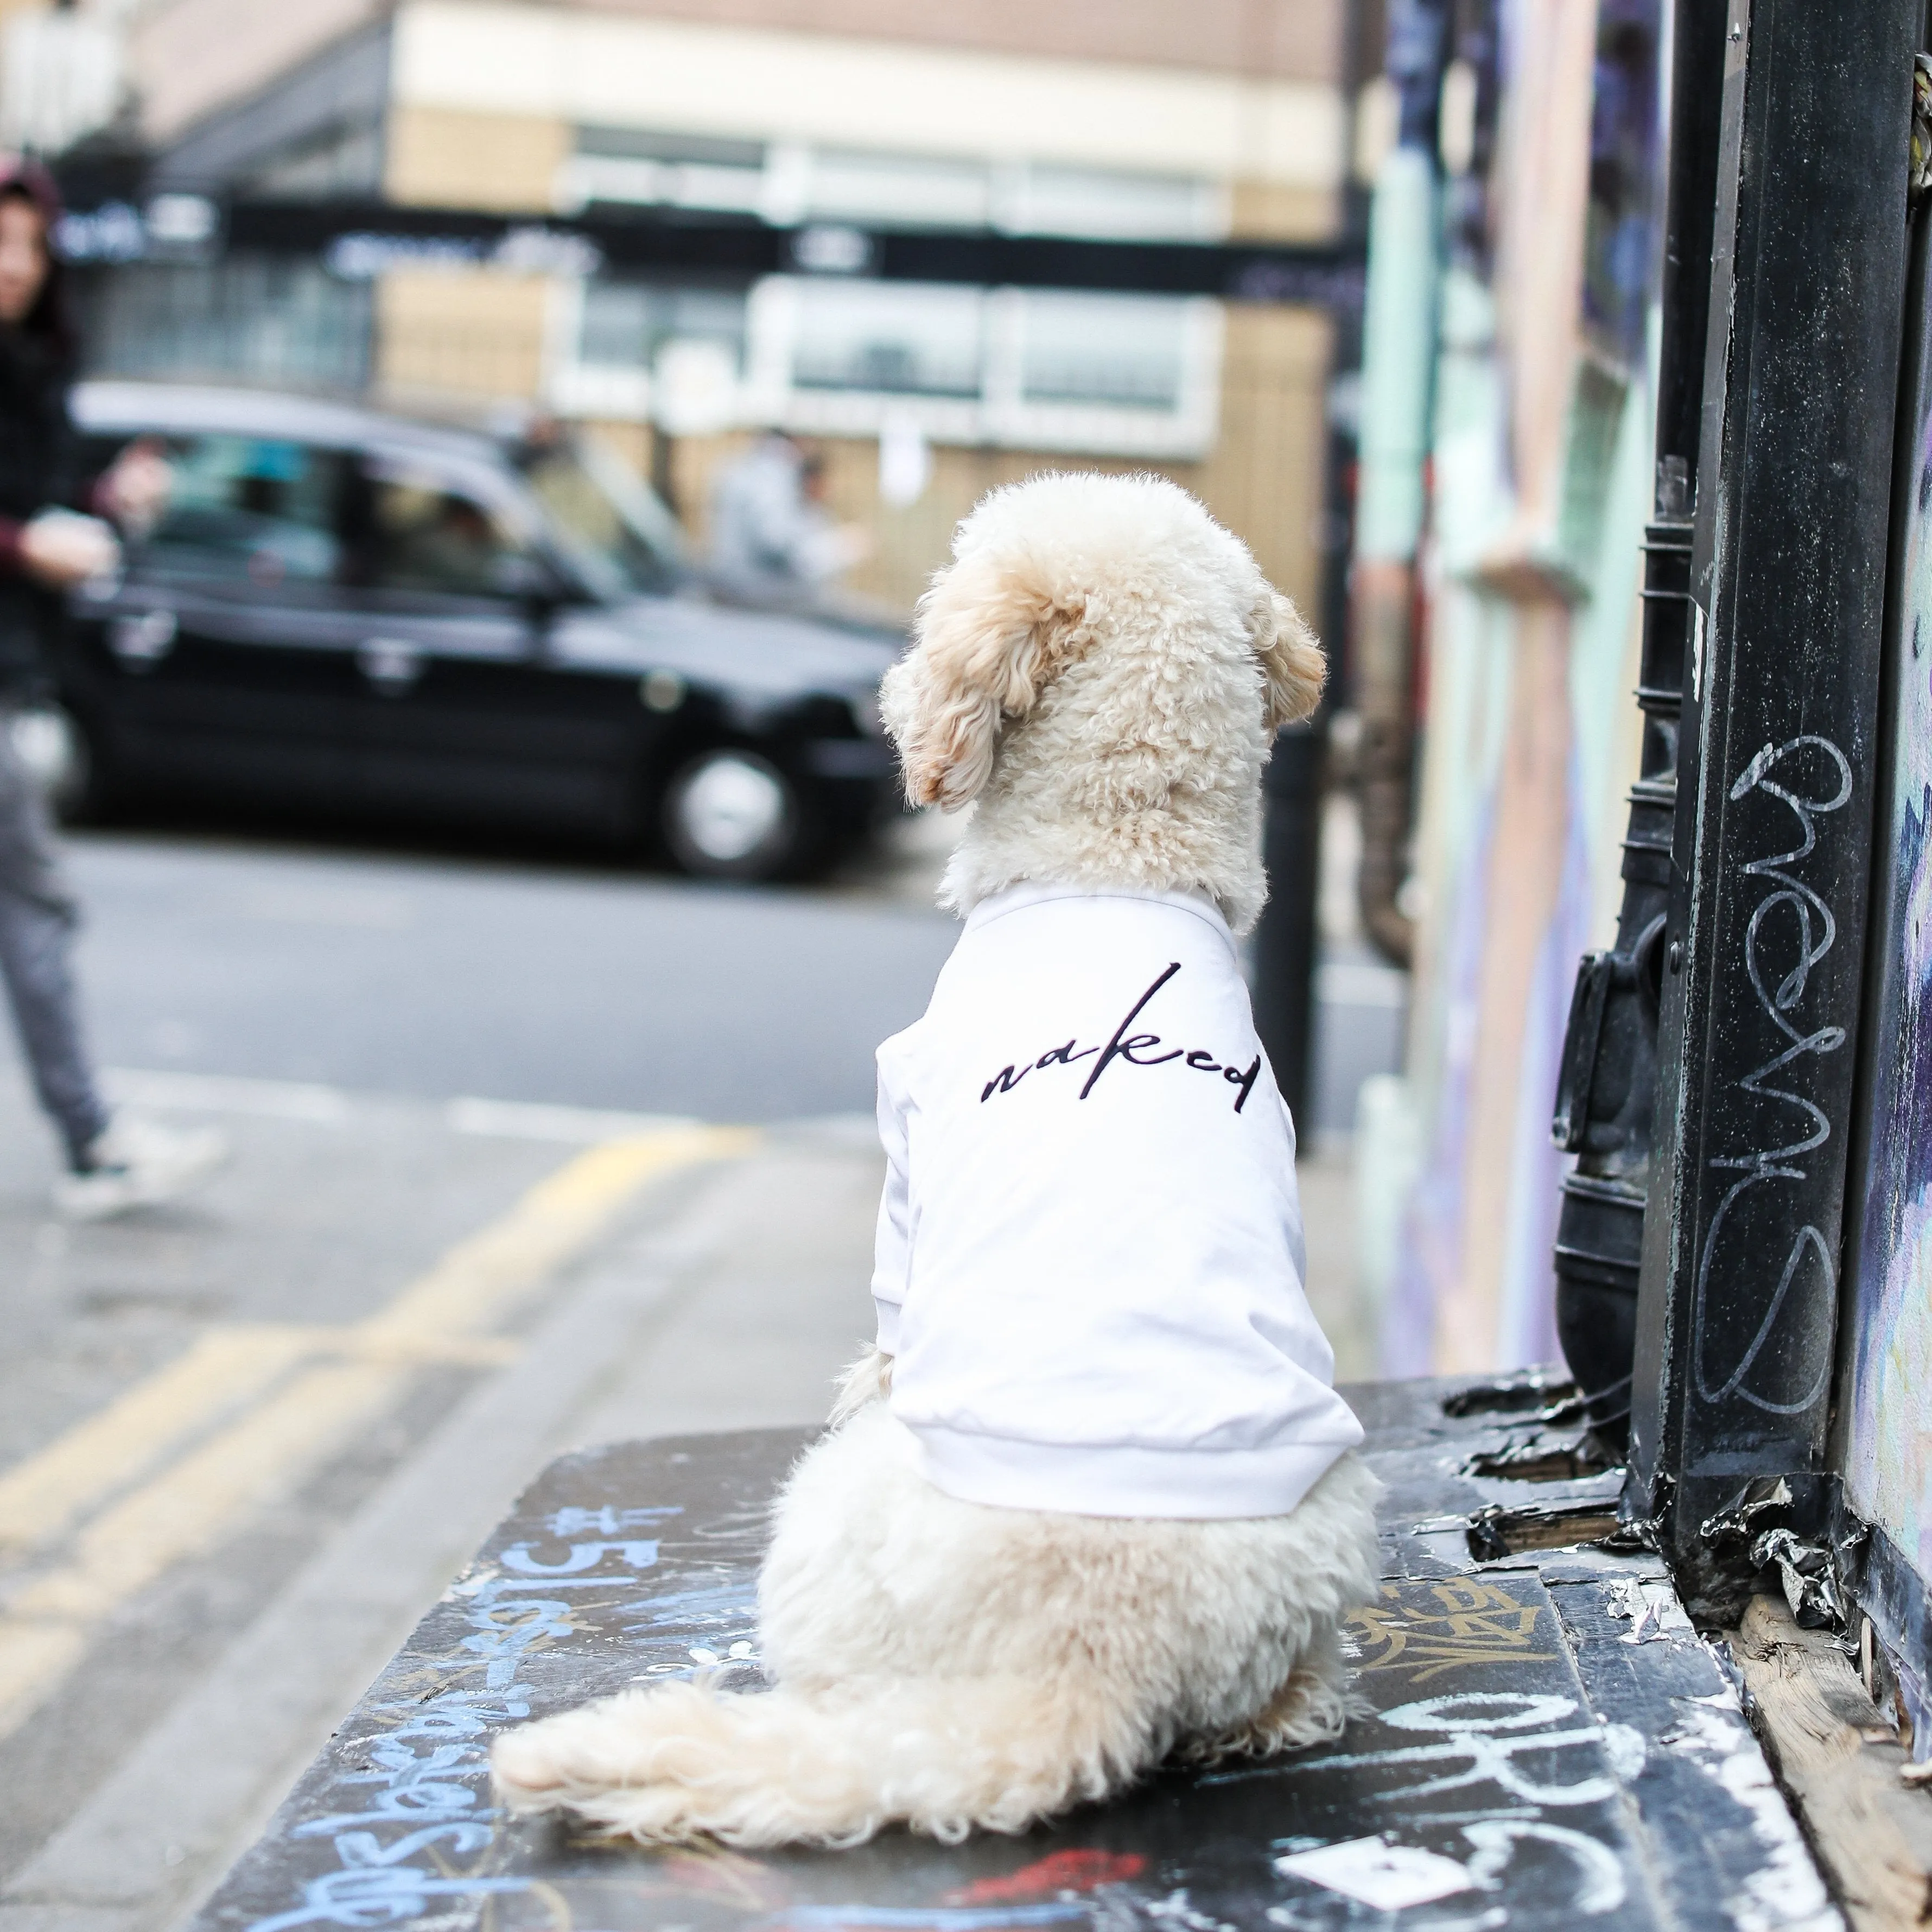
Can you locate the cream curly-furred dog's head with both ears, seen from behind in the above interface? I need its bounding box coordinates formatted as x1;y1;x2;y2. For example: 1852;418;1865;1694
881;475;1325;811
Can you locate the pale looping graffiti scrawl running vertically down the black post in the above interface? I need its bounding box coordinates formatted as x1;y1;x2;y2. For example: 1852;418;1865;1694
1690;732;1851;1416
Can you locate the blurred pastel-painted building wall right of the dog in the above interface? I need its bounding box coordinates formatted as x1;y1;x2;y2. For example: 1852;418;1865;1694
1356;0;1666;1374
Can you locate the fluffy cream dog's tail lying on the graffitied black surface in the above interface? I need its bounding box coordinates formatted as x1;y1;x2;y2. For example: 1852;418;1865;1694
493;1677;1143;1847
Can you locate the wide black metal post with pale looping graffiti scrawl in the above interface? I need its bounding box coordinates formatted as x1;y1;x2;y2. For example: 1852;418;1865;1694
1632;0;1924;1609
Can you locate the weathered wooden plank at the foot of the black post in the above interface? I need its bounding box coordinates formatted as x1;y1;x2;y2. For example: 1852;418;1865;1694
1731;1596;1932;1932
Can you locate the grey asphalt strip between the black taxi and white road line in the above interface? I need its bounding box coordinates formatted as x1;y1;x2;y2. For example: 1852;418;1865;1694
41;823;1403;1134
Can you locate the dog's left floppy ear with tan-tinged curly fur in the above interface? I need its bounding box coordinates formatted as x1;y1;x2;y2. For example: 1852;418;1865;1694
879;551;1086;811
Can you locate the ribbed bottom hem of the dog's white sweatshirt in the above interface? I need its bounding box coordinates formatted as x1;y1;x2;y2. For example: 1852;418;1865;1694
906;1424;1362;1518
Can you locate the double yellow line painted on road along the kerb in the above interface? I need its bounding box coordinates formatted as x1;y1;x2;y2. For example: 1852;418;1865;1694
0;1126;758;1737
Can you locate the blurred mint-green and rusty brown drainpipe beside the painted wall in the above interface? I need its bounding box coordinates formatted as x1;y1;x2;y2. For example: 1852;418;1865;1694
1350;0;1449;966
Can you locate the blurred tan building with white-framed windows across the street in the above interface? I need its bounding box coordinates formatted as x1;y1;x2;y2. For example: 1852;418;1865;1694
30;0;1360;605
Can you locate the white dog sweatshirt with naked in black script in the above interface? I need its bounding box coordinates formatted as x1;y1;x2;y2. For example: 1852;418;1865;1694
872;885;1362;1517
